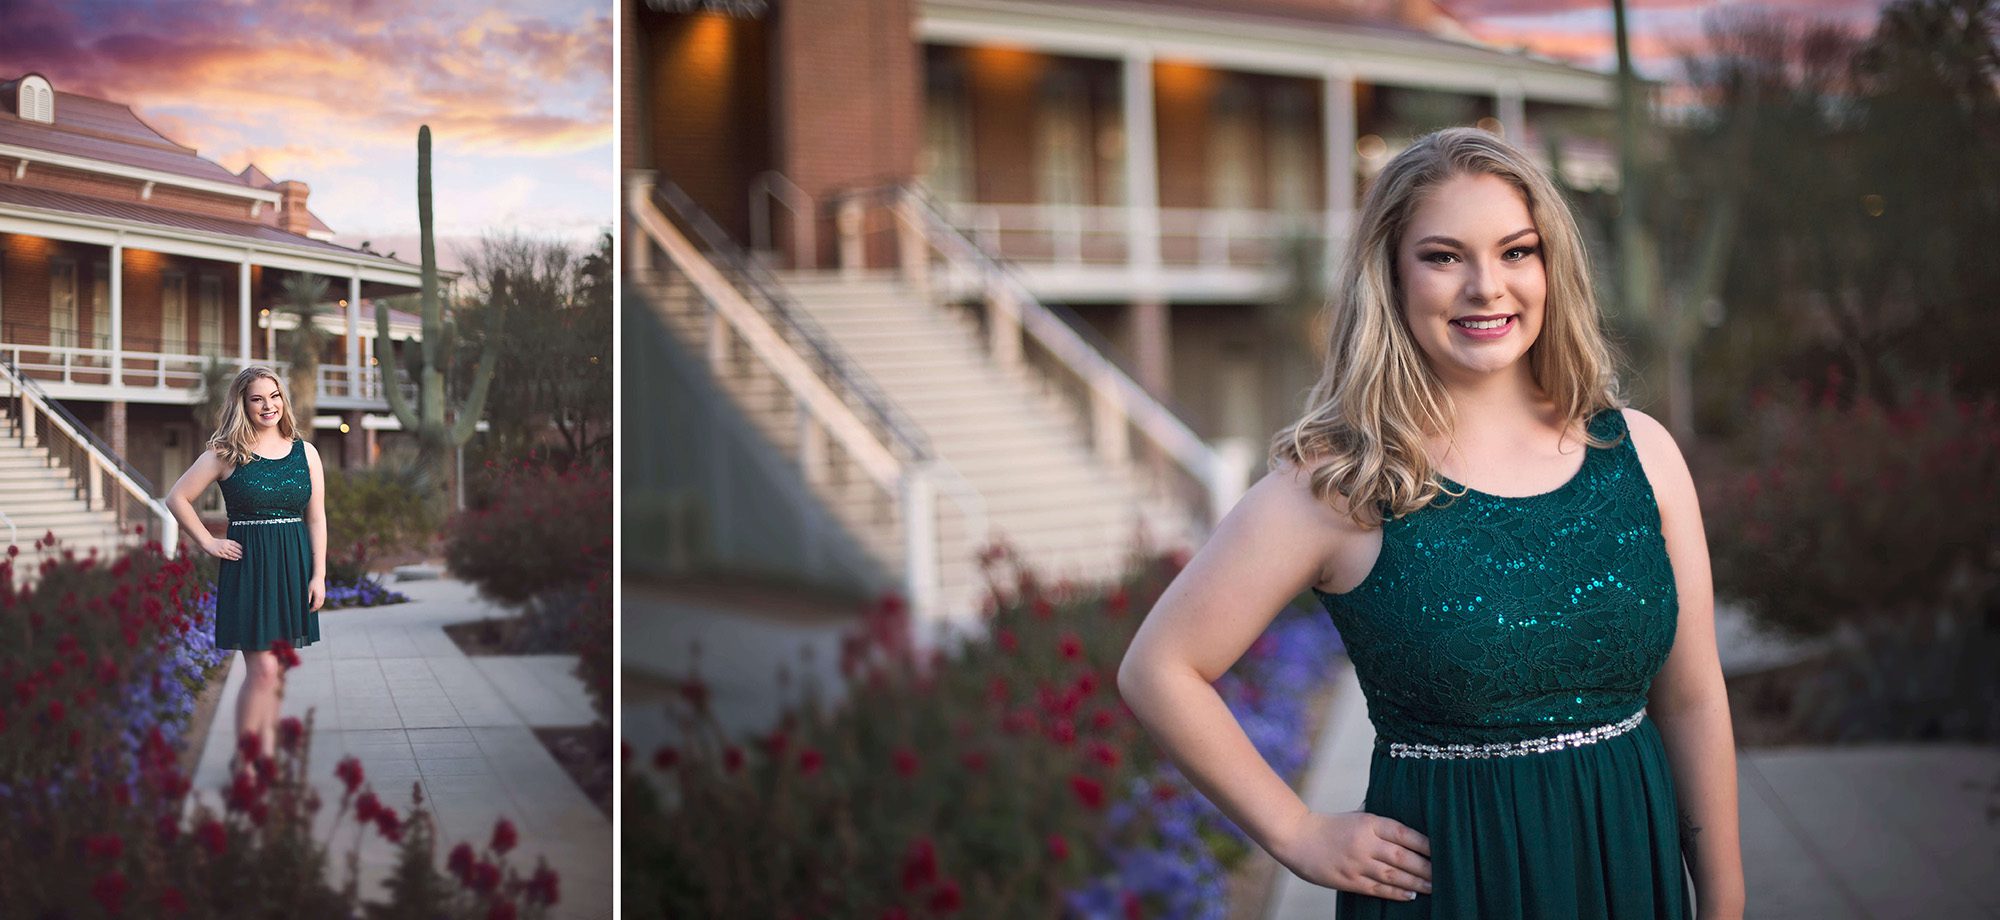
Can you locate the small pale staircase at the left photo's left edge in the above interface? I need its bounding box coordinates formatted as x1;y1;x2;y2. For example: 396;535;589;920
0;400;140;582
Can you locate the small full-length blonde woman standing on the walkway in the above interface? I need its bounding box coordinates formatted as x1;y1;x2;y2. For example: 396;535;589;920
166;364;326;754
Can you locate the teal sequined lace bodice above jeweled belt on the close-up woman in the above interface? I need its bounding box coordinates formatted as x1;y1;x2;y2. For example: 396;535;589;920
1314;408;1678;744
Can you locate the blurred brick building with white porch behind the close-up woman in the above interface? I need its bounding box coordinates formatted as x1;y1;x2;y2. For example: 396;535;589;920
622;0;1616;452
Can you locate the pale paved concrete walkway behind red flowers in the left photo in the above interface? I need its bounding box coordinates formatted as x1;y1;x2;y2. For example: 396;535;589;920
194;580;612;920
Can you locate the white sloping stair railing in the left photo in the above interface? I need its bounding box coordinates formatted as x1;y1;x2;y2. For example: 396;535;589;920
0;352;180;554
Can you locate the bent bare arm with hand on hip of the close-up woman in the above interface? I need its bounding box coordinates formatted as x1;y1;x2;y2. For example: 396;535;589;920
1118;466;1430;900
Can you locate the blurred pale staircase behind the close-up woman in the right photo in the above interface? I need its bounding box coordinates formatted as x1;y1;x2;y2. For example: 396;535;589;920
640;272;1192;610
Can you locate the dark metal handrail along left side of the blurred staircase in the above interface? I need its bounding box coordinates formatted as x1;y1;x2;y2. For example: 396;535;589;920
654;180;934;460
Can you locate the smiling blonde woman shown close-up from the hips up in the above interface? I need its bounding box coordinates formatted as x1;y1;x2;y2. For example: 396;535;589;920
1118;128;1744;920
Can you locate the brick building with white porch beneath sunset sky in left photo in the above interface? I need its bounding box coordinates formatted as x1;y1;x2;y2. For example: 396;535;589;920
0;74;420;490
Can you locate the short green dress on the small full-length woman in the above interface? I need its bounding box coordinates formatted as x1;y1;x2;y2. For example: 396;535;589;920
216;440;320;652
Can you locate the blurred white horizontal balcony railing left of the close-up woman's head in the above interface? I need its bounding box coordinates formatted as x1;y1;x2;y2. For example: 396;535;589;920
936;202;1326;268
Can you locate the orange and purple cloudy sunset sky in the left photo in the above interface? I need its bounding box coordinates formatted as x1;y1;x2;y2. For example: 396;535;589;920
0;0;616;262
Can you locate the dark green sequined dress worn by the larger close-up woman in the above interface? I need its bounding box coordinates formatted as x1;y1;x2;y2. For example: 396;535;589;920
1314;408;1692;920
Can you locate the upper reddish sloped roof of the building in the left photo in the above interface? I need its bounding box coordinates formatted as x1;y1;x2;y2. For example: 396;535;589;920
0;78;258;188
